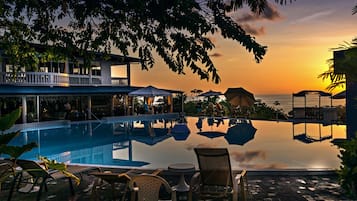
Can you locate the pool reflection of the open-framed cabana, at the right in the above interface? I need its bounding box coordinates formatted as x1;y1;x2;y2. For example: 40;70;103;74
292;122;333;144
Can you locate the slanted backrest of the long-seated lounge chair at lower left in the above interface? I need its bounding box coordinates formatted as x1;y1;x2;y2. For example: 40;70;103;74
16;159;51;178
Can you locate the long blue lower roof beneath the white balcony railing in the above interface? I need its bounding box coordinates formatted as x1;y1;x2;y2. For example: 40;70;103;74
0;85;182;96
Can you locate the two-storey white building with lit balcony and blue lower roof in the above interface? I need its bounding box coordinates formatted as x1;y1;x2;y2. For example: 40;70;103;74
0;45;181;123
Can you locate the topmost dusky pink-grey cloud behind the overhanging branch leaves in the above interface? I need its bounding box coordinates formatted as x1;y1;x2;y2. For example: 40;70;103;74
234;3;283;23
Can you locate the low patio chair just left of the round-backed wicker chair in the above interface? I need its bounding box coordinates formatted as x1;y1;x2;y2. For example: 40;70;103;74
90;169;162;200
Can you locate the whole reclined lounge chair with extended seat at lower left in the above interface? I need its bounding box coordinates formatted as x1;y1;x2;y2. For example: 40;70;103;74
9;160;98;201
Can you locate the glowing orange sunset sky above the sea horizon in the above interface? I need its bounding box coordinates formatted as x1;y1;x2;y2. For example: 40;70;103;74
112;0;357;94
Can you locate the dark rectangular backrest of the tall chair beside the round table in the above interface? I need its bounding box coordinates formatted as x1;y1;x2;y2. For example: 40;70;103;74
194;148;233;187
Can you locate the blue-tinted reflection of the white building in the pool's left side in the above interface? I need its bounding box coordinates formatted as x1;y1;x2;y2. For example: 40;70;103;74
12;123;149;167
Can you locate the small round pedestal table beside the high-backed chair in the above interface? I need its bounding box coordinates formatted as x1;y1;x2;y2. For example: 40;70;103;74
168;163;195;192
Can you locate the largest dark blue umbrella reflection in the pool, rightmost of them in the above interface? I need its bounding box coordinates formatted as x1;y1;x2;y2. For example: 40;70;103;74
224;123;257;145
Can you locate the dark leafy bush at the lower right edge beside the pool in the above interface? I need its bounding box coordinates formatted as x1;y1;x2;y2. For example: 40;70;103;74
336;137;357;198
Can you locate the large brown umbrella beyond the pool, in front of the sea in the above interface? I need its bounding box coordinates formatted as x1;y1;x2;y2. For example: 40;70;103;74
224;87;255;107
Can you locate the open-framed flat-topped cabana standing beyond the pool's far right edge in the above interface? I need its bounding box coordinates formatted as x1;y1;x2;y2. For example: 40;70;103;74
292;90;337;124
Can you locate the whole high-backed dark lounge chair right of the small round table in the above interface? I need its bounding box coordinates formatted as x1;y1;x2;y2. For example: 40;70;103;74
189;148;247;201
